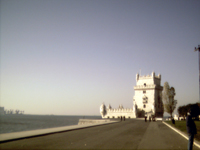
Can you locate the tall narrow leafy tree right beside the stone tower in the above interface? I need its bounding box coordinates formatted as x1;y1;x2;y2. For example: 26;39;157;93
161;82;177;118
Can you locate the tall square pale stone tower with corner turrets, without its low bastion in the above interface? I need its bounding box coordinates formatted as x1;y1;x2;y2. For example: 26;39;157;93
133;72;164;117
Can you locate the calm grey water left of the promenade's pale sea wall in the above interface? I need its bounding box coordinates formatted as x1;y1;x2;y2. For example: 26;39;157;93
0;115;101;134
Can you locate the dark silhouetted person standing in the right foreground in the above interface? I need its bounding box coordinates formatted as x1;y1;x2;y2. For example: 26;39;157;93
186;109;197;150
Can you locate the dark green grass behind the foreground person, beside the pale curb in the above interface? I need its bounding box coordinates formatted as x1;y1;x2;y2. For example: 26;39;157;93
165;121;200;141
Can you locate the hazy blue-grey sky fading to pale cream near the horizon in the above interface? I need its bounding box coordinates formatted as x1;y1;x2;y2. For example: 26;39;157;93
0;0;200;115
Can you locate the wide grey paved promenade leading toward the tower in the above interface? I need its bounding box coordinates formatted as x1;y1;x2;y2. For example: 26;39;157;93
0;120;198;149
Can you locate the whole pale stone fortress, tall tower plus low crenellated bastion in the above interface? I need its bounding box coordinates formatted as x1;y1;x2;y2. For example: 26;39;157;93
100;72;164;118
